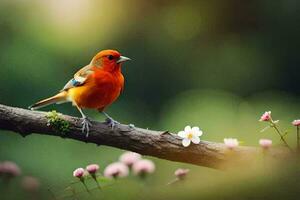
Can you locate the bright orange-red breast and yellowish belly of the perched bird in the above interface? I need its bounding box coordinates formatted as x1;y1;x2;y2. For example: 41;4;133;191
68;67;124;111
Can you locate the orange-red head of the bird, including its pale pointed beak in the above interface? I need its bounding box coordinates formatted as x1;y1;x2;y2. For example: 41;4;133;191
91;50;131;71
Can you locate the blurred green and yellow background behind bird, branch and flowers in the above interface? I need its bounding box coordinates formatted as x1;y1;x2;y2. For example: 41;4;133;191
0;0;300;200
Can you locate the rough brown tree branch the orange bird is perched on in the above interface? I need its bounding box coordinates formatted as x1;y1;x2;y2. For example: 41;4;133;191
0;104;286;169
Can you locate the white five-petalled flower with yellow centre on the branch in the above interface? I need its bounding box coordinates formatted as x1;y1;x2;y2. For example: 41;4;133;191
178;126;202;147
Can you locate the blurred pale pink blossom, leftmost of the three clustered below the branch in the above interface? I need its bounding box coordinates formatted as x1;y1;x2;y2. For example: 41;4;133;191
104;162;129;178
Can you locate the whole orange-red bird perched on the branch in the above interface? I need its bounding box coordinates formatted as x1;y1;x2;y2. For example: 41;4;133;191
29;50;130;137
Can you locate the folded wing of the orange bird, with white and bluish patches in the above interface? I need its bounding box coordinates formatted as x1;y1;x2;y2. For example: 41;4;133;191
61;65;93;91
